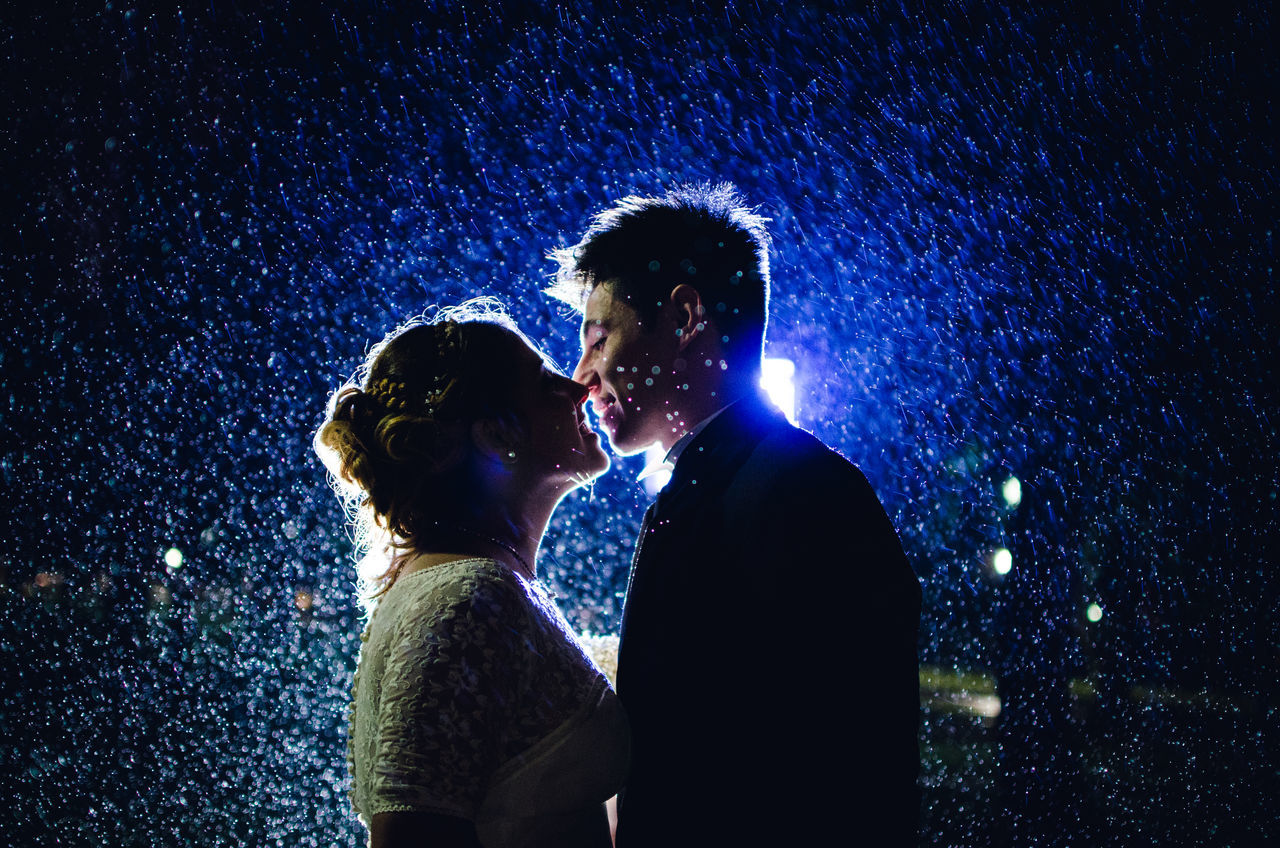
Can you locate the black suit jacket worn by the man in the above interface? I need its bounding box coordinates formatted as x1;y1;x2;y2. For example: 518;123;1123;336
617;396;920;848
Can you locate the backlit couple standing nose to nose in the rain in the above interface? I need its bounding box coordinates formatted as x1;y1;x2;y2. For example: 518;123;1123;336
316;186;920;848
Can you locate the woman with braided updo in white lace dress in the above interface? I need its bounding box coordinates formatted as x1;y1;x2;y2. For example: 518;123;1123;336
316;305;630;848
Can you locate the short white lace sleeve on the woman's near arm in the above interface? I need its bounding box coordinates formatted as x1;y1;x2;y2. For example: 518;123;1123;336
366;573;530;819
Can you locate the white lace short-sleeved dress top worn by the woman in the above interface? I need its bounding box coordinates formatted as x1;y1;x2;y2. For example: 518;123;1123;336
348;559;630;848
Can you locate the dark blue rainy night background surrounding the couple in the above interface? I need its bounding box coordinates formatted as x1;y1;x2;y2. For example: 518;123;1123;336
0;0;1280;845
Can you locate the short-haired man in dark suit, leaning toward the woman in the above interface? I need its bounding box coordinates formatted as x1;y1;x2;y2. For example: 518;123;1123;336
550;186;920;848
